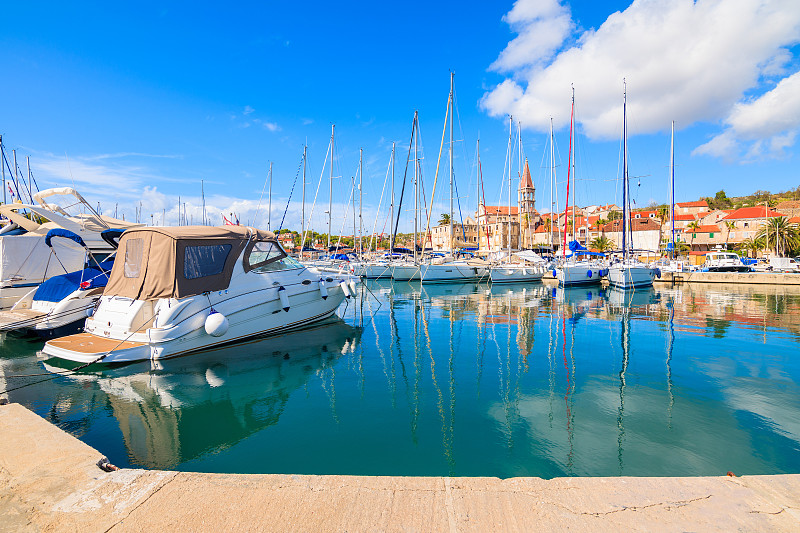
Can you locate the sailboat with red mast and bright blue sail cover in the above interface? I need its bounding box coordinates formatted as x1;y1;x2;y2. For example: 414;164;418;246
555;88;606;287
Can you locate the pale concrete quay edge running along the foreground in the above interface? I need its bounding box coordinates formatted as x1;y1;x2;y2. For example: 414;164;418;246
0;404;800;533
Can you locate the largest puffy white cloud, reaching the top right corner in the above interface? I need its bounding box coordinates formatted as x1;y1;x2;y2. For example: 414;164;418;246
481;0;800;148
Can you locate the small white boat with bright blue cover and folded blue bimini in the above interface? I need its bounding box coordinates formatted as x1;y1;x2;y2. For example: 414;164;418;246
0;229;122;338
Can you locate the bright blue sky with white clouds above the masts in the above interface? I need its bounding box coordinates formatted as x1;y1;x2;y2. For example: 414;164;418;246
0;0;800;232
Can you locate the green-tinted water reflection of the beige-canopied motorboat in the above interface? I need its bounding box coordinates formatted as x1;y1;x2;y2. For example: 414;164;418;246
40;318;360;469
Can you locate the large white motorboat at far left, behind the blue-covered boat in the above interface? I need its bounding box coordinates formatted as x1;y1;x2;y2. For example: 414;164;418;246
0;187;141;310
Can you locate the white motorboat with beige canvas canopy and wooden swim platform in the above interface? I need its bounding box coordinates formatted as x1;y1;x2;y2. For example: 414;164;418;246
43;222;357;363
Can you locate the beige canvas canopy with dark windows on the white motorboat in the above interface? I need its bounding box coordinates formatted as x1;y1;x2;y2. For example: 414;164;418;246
104;226;277;300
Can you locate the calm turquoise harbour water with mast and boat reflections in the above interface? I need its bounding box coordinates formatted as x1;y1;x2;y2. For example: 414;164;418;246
0;282;800;478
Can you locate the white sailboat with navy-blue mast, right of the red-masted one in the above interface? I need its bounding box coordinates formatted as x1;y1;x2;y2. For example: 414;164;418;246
608;80;656;289
